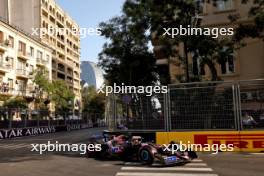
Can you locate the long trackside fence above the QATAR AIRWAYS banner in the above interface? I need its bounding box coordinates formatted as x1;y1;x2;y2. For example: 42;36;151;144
0;108;105;129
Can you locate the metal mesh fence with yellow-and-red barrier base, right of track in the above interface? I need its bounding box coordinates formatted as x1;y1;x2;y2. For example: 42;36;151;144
107;79;264;152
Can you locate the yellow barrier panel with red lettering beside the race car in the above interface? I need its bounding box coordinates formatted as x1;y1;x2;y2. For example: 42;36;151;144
156;131;264;152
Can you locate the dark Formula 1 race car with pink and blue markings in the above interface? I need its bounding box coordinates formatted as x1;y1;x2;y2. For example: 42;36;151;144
87;133;197;166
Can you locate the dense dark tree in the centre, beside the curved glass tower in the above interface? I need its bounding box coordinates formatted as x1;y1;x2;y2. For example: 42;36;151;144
99;15;157;86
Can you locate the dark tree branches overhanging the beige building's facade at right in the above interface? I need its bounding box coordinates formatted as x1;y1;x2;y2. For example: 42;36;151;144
123;0;233;84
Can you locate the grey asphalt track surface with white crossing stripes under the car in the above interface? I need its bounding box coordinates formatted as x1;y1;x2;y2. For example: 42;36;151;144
0;128;264;176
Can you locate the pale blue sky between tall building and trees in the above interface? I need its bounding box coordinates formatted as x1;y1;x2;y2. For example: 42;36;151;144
56;0;125;62
